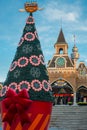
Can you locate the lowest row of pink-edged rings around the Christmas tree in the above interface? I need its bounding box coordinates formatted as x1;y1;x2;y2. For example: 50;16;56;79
1;79;52;96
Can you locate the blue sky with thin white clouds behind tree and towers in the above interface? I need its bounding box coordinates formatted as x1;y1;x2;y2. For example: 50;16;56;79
0;0;87;82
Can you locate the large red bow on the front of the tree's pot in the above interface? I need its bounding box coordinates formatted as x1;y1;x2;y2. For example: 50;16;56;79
2;89;32;125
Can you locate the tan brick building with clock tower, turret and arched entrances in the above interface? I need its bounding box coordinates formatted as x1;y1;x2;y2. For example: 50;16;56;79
47;29;87;104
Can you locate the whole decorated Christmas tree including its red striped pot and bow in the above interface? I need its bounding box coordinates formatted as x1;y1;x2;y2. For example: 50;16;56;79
1;3;53;130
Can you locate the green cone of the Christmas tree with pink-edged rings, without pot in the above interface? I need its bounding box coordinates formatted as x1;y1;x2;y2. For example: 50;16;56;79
2;13;53;101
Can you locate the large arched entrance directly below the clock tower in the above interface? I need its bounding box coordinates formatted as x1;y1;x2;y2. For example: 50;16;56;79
51;79;73;105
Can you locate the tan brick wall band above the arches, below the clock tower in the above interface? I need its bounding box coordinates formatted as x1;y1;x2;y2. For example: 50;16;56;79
47;68;87;92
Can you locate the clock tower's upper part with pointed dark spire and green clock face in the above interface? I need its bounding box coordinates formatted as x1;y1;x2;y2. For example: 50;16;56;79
48;28;73;69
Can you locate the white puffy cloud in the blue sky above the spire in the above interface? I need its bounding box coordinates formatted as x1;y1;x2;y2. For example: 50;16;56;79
44;1;80;22
